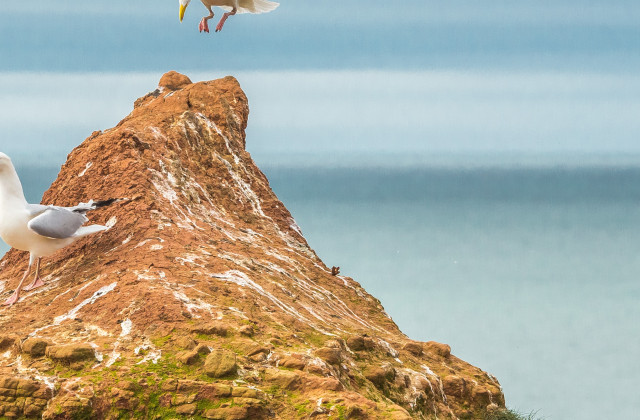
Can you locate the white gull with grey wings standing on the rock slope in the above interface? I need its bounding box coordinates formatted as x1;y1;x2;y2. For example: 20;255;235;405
0;152;120;306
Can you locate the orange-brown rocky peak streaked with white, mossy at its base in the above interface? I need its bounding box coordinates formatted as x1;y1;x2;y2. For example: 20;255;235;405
0;73;504;419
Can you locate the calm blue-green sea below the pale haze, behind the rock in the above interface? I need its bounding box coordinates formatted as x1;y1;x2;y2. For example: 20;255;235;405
0;165;640;420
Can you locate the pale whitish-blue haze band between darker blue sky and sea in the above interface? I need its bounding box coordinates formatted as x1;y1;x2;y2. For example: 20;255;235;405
0;69;640;166
